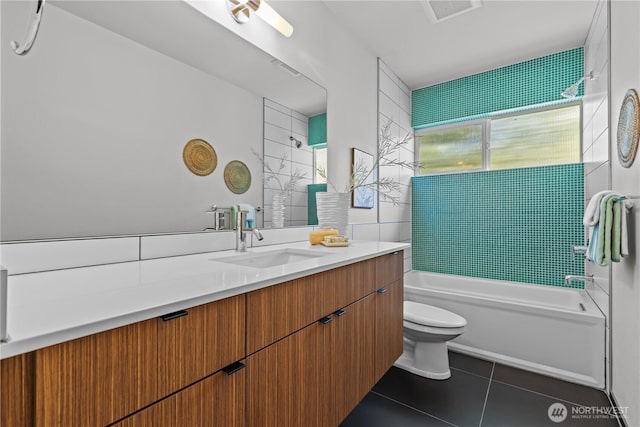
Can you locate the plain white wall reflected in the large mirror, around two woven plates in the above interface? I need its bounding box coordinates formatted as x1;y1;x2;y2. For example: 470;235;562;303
0;1;263;241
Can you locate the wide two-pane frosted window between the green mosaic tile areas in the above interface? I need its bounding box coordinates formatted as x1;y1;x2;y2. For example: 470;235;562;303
416;104;582;174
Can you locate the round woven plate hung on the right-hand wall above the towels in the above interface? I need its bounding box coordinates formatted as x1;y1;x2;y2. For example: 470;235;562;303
618;89;640;168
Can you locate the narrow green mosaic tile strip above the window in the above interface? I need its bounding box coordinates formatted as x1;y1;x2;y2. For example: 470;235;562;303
411;47;584;129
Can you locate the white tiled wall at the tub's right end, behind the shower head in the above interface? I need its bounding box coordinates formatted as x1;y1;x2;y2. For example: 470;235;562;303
582;1;611;389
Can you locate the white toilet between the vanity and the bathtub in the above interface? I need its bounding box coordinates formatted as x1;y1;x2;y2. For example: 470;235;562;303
395;301;467;380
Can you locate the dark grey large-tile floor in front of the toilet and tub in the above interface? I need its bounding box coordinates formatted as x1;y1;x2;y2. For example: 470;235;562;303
341;352;618;427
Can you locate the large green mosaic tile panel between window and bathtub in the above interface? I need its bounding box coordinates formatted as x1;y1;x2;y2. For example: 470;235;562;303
411;163;584;288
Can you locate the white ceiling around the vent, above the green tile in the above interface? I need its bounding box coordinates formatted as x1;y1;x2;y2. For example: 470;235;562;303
324;0;597;89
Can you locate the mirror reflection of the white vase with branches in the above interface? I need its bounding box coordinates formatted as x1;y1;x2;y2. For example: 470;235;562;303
251;149;306;228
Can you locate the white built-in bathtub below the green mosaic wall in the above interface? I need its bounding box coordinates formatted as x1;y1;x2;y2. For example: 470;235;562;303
404;270;605;389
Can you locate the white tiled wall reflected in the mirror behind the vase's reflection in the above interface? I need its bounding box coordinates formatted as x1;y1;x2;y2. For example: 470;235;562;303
263;98;314;227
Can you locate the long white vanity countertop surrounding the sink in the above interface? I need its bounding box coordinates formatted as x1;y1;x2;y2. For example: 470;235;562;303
0;241;410;359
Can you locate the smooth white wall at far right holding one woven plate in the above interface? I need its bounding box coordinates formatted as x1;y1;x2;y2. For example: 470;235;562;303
610;0;640;426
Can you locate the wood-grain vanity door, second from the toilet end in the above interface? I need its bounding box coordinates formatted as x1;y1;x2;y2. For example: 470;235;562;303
332;294;375;426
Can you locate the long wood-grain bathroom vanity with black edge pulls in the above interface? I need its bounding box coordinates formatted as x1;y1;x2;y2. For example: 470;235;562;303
0;242;406;427
